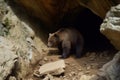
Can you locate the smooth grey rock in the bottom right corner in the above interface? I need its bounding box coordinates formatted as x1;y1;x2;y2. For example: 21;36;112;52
90;52;120;80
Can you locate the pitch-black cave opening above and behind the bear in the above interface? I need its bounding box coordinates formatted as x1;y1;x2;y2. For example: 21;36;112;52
59;8;114;51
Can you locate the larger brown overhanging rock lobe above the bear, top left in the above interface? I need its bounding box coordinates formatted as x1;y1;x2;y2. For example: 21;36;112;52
8;0;79;26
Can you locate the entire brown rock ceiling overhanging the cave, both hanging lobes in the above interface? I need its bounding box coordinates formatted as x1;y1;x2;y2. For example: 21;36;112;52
6;0;119;27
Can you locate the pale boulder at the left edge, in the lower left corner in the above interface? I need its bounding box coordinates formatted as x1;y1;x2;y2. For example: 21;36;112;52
0;37;18;80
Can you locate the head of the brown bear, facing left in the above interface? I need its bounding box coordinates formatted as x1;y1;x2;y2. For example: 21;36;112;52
47;33;59;47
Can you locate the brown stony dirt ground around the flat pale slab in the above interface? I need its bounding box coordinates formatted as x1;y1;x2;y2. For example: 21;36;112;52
26;50;116;80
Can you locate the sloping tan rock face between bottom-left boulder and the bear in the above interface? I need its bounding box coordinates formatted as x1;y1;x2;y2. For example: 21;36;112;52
0;7;44;80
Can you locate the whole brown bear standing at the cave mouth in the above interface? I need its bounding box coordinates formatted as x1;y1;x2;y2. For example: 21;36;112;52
47;27;84;58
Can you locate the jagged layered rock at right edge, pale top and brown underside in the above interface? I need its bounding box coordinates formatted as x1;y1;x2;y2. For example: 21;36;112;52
100;5;120;50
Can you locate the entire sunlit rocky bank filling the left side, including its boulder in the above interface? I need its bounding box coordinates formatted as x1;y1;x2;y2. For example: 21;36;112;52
0;6;46;80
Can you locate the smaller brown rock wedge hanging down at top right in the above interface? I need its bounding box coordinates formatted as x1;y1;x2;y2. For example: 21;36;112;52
78;0;115;19
